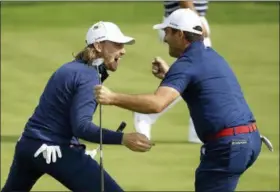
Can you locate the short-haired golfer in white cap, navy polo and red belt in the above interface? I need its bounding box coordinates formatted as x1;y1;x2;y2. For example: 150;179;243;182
95;9;261;192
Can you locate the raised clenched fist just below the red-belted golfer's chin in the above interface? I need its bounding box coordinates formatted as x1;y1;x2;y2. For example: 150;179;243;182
152;57;169;79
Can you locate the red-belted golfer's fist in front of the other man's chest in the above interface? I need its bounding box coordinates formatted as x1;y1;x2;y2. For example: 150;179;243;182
94;85;114;105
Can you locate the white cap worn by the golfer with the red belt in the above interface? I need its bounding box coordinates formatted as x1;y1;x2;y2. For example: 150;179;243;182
153;8;202;35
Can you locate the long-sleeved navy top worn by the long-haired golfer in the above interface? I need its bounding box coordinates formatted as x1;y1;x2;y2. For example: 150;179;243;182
23;60;123;144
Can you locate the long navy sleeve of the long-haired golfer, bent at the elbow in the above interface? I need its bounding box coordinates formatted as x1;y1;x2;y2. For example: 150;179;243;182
70;71;123;144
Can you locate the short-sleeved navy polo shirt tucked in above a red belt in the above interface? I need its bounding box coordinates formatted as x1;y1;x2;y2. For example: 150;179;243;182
160;42;255;141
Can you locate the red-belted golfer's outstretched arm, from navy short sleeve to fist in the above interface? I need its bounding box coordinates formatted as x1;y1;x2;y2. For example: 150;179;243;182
95;59;193;114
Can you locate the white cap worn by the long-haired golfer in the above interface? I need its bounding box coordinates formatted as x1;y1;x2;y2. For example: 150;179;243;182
86;21;135;45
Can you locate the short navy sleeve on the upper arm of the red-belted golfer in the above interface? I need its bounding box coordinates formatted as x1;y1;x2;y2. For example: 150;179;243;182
160;57;195;94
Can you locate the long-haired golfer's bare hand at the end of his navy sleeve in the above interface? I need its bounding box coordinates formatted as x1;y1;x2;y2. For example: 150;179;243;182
122;133;153;152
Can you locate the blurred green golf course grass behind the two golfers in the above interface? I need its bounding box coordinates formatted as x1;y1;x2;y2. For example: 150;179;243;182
1;2;279;191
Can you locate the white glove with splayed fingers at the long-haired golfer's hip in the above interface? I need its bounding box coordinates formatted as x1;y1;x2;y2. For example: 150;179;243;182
34;144;62;164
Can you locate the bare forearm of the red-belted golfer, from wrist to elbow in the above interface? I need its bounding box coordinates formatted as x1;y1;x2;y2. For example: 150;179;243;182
112;93;163;114
